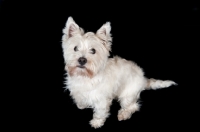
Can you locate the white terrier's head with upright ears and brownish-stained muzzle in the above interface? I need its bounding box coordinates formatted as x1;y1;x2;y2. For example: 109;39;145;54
62;17;112;78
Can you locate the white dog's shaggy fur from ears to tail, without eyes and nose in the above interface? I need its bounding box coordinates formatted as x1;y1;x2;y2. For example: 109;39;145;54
62;17;176;128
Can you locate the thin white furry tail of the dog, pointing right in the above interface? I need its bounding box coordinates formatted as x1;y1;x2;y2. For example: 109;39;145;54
145;78;177;90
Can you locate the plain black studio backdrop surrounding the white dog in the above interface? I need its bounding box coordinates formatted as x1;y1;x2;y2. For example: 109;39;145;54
0;0;200;132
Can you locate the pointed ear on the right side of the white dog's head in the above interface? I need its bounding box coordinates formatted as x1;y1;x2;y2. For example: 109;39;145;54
96;22;112;51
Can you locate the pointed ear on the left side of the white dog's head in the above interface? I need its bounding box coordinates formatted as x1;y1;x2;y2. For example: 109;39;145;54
63;17;83;38
